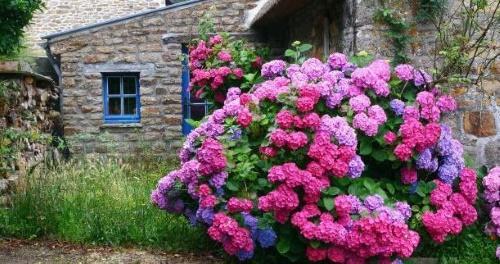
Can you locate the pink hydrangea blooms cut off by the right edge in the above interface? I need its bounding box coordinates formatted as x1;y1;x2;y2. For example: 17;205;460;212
483;166;500;259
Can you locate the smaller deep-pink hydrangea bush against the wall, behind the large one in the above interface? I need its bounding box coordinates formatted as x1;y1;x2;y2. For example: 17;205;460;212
189;34;266;106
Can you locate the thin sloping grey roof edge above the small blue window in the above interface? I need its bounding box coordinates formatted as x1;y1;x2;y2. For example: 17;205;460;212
42;0;207;40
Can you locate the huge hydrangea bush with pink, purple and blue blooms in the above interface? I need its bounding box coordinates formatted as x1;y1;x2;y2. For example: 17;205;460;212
151;53;477;263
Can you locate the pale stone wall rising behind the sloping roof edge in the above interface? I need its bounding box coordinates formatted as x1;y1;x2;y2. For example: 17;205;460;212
26;0;165;52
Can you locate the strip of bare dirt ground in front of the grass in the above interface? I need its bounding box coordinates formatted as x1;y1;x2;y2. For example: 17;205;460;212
0;239;223;264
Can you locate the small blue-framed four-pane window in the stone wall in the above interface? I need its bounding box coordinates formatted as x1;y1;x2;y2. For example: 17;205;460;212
102;73;141;123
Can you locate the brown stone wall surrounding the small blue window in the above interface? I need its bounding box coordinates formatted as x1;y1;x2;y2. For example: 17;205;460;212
50;0;260;154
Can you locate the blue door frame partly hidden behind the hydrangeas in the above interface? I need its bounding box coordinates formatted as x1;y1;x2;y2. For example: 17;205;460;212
182;45;212;135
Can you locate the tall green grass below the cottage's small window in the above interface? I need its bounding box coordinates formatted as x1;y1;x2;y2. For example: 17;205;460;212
0;158;210;252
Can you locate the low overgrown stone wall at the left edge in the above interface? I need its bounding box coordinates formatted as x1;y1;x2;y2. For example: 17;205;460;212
0;61;62;206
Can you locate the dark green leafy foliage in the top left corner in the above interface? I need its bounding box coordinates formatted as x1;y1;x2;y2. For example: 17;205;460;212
0;0;44;55
